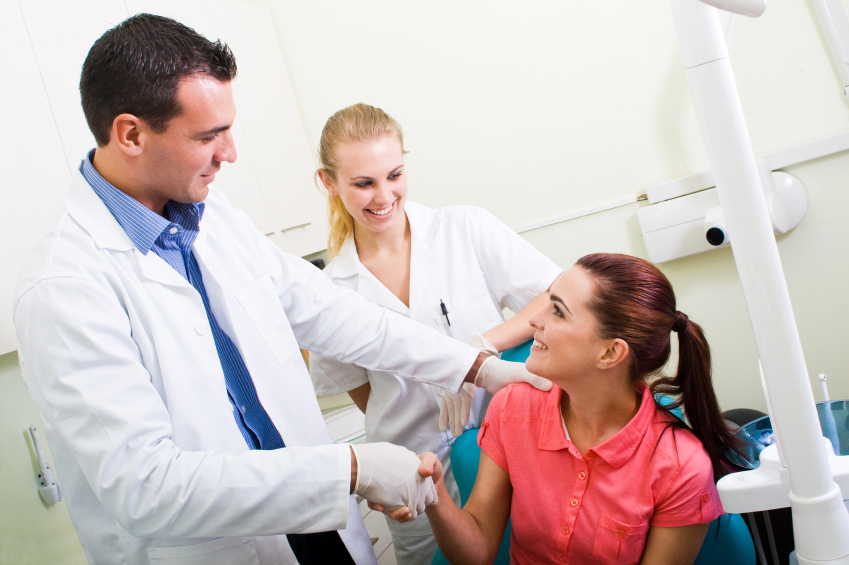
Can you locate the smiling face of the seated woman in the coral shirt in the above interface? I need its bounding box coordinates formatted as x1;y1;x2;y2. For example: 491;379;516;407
525;266;608;385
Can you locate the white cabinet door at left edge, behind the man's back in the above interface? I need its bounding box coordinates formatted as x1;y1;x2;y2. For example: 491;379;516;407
0;0;70;355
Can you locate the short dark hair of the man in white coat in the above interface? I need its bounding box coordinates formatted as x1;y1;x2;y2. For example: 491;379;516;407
80;14;237;147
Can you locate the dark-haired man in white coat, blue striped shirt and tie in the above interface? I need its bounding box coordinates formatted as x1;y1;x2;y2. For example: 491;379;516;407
9;14;524;565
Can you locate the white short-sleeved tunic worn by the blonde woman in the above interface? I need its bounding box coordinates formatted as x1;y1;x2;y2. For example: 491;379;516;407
310;201;562;537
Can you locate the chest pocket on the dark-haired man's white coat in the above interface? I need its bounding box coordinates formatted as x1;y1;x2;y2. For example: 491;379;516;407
236;273;298;365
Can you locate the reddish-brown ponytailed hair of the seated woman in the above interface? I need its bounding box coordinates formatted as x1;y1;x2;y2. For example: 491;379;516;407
576;253;739;480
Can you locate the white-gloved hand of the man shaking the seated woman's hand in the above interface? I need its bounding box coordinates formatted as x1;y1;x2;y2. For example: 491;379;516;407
351;443;437;518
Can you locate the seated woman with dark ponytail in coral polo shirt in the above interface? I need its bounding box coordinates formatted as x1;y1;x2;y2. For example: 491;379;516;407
384;254;734;564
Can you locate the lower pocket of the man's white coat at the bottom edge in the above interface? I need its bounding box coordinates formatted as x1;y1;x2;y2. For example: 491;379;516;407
147;538;259;565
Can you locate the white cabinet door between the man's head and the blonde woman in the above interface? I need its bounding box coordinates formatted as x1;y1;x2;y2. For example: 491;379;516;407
127;0;326;255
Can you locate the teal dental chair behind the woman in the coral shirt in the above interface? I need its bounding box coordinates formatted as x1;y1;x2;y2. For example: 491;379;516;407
433;341;756;565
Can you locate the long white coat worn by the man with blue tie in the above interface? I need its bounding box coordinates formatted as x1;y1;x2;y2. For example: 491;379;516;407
14;171;477;565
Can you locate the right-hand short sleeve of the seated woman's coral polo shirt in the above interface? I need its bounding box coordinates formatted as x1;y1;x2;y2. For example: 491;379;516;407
651;444;725;528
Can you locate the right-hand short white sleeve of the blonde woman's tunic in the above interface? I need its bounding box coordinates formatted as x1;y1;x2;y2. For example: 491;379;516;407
470;207;563;312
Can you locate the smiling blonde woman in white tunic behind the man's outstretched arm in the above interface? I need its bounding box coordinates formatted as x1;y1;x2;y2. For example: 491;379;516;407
310;104;561;565
